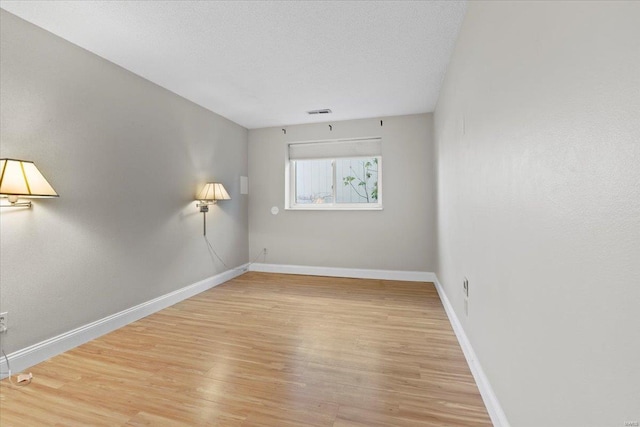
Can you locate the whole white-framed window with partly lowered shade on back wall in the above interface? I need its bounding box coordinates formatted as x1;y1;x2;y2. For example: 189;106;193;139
285;138;382;210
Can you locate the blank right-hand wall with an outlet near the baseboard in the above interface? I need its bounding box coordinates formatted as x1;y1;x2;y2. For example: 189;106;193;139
435;2;640;427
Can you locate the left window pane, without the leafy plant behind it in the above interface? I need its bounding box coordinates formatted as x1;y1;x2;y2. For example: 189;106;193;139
295;160;333;204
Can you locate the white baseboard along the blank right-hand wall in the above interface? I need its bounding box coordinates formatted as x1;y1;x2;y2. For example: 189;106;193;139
434;277;509;427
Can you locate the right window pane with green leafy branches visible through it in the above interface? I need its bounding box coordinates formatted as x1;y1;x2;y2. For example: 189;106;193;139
336;157;379;203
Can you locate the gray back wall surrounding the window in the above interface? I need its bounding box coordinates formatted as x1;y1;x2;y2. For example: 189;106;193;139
249;114;435;271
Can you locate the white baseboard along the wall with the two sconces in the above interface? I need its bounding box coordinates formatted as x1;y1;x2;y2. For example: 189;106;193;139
0;264;248;379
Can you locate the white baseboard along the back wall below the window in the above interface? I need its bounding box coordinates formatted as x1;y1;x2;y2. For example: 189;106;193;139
249;263;436;282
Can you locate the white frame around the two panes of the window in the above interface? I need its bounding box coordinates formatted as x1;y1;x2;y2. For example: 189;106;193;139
284;138;383;211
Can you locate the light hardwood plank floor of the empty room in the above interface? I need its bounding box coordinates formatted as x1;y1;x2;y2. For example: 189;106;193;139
0;272;491;427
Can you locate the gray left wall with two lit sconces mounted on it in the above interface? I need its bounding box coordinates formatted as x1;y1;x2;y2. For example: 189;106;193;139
0;11;248;352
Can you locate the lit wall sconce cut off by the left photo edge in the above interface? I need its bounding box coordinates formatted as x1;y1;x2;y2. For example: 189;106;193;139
0;159;59;208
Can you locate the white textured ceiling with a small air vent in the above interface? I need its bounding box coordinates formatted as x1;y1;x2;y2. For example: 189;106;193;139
0;0;465;129
